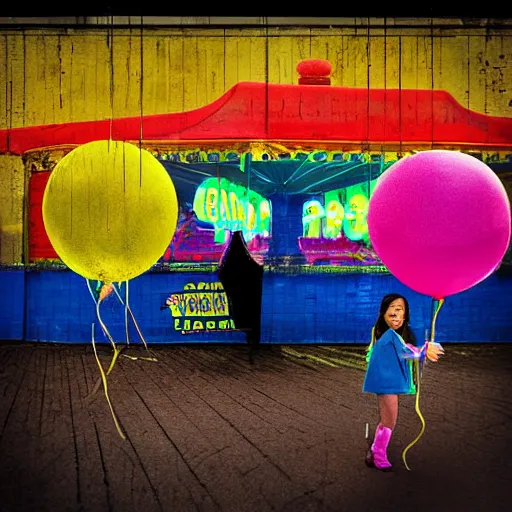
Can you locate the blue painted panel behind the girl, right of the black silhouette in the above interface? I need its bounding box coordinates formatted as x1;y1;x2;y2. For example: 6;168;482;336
262;273;512;343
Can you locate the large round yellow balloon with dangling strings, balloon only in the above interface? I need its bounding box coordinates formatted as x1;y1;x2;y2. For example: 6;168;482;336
43;140;178;283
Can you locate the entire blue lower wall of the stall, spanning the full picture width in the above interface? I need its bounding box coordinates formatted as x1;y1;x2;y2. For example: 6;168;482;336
0;270;512;343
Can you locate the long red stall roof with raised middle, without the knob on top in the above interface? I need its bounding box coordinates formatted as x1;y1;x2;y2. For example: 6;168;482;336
0;82;512;154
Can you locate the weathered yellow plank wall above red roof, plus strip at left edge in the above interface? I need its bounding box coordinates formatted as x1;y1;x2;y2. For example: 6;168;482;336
0;26;512;263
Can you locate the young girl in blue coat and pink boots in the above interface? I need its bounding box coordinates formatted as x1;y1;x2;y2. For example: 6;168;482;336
363;293;442;471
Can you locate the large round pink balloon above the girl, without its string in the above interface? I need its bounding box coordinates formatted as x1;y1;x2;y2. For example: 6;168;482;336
368;151;511;299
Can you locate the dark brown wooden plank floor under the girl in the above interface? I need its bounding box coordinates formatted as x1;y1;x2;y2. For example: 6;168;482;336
0;342;512;512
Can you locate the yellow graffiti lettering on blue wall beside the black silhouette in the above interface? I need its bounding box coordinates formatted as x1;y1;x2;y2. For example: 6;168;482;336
162;282;235;334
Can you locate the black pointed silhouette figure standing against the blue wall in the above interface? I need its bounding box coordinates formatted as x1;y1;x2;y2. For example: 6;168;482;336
218;231;263;364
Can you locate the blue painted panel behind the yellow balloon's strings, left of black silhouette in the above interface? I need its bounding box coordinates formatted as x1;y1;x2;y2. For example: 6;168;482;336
27;271;245;343
